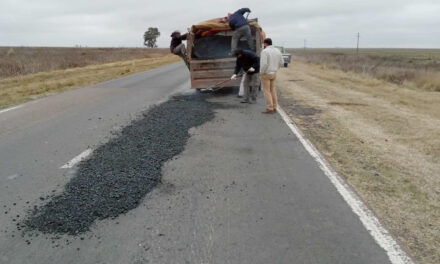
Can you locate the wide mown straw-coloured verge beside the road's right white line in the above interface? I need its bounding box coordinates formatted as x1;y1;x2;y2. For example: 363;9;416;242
277;58;440;264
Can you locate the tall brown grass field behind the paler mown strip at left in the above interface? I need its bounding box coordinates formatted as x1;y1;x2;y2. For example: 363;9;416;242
0;47;169;78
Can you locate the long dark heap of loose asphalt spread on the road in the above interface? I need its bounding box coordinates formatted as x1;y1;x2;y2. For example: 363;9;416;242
24;94;214;235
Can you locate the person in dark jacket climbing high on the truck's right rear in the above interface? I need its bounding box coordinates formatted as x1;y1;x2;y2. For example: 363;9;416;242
229;8;255;54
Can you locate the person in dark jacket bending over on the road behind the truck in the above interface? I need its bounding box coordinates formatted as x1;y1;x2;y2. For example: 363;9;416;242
231;49;260;104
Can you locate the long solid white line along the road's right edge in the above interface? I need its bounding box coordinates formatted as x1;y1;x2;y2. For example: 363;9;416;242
277;107;414;264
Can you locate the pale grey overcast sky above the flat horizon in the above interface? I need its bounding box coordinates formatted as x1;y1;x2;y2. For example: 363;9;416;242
0;0;440;48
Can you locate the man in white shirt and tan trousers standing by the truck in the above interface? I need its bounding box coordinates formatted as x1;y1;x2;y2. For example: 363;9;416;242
260;38;284;114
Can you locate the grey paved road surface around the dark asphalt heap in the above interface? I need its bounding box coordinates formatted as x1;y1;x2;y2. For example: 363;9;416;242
0;64;390;264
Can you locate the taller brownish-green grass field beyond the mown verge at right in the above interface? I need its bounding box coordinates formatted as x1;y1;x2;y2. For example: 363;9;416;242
290;49;440;91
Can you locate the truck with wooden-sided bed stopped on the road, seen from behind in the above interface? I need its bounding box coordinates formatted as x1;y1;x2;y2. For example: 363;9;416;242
187;18;264;90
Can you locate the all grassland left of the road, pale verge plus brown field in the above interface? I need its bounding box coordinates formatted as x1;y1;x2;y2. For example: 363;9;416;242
0;48;179;109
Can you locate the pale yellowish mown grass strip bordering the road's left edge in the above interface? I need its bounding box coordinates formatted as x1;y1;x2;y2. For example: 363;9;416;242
0;55;179;109
